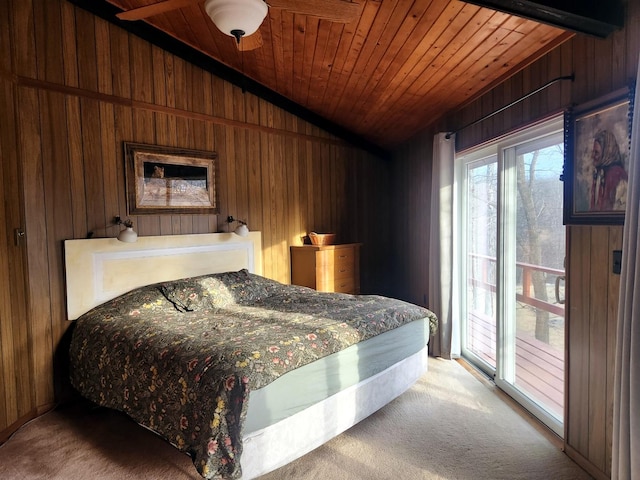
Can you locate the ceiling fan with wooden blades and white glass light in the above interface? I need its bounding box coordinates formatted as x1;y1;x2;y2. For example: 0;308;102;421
116;0;360;50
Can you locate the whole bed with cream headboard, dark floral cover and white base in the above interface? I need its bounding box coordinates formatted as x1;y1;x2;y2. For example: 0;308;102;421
65;232;437;479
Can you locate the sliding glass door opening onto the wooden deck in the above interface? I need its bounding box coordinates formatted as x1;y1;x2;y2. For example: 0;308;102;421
458;116;565;435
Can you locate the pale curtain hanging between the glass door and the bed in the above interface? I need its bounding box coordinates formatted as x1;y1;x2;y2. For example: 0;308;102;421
429;133;460;358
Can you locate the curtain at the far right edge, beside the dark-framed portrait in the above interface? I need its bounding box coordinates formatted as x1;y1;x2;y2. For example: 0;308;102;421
611;52;640;480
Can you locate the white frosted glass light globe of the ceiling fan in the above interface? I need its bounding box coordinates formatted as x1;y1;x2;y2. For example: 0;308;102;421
204;0;269;37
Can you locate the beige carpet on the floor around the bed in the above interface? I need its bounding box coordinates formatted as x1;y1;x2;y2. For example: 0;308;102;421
0;359;591;480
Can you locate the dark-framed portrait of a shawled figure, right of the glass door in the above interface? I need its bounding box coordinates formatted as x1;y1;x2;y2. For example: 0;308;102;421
563;87;634;225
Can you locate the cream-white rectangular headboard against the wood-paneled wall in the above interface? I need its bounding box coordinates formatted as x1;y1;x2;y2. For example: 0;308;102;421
64;232;262;320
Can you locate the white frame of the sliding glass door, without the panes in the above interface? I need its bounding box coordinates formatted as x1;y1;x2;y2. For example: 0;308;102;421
454;115;566;437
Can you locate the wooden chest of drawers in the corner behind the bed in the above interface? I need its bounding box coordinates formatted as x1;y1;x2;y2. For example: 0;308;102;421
291;243;362;294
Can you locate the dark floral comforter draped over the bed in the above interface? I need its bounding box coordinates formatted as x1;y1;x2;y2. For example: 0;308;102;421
70;270;437;479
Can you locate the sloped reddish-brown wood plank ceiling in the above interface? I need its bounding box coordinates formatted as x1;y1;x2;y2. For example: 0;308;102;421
92;0;573;150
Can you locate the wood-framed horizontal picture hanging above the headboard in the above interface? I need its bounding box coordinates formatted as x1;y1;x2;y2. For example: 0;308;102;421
124;142;218;215
